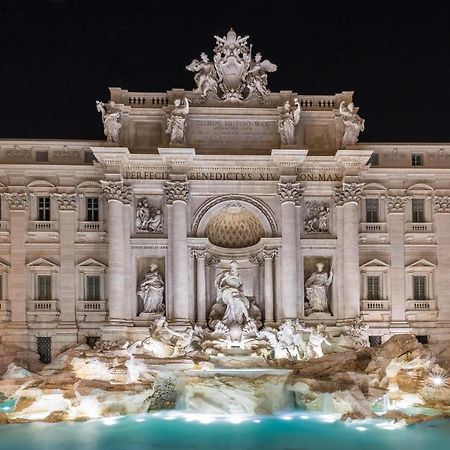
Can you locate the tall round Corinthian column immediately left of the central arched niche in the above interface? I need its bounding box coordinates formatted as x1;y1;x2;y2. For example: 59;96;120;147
164;181;189;323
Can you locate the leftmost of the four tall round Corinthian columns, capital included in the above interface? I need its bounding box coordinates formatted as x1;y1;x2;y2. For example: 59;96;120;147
102;181;131;322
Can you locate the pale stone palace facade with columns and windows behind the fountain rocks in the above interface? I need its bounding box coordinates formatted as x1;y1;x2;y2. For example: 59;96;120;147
0;29;450;361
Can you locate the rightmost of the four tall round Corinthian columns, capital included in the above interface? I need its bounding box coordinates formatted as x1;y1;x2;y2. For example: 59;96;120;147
335;183;364;319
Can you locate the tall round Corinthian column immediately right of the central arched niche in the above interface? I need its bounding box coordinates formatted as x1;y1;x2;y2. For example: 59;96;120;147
278;183;303;320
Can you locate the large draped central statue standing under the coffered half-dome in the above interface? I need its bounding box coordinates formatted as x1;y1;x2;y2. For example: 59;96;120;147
208;261;261;329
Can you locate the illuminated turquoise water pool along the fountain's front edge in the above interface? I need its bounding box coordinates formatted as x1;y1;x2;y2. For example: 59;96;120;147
0;412;450;450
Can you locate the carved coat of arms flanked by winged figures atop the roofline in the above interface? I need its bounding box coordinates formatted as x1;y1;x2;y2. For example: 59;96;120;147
186;29;277;102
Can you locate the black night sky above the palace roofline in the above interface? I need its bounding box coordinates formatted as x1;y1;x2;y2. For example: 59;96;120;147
0;0;450;142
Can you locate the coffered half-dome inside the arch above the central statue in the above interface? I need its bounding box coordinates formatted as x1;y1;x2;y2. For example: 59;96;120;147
205;204;265;248
